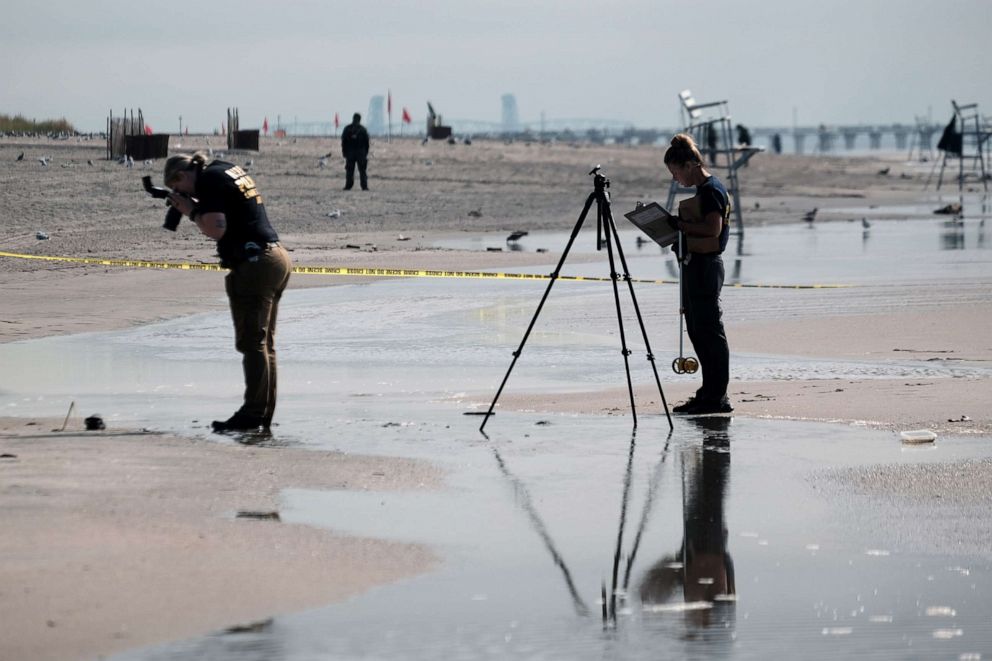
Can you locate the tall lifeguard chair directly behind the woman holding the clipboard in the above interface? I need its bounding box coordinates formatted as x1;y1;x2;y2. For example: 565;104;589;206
665;90;765;236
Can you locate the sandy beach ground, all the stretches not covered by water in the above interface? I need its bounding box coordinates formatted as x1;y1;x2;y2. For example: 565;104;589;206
0;136;992;659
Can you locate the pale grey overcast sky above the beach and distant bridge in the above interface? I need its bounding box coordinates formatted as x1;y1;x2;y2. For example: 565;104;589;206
0;0;992;132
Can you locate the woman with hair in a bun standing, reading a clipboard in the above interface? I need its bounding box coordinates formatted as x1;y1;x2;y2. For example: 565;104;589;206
665;133;734;414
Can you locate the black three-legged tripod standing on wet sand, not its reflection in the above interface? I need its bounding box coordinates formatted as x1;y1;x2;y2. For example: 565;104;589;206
479;165;674;431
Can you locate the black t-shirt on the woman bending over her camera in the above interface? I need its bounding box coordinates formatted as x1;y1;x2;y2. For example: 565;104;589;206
195;161;279;262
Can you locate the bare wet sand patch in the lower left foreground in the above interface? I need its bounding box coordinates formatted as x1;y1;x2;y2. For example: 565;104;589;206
0;417;443;659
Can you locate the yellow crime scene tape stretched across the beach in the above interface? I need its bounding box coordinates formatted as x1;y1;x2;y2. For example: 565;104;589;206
0;251;853;289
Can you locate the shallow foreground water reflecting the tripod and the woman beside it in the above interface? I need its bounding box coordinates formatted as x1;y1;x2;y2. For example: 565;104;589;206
108;414;992;660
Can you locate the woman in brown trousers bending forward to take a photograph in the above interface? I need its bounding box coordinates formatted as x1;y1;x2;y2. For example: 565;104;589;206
165;152;292;432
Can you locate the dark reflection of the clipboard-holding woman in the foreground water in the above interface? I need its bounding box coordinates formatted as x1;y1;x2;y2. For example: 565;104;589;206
639;416;737;629
